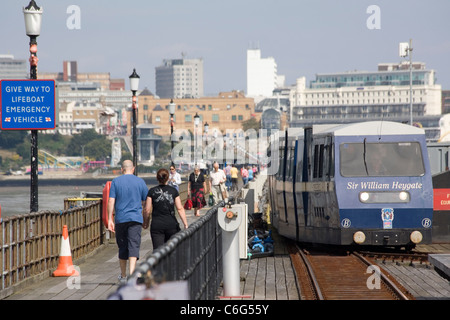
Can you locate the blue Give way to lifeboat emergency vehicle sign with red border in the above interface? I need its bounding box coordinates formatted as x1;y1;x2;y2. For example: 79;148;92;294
0;80;56;130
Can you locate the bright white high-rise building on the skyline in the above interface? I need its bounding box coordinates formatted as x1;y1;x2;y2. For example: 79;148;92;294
247;49;278;97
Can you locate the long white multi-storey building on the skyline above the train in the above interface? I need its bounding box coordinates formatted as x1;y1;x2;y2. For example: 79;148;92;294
290;63;442;139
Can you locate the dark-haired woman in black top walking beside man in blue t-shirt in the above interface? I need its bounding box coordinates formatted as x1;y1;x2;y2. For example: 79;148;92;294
143;169;188;250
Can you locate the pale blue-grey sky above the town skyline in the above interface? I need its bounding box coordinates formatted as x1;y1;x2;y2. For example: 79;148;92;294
0;0;450;95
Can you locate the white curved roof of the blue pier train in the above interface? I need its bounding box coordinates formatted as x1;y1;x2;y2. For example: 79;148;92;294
313;121;425;136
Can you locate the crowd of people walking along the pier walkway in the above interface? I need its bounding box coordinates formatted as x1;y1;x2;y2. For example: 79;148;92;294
107;160;258;282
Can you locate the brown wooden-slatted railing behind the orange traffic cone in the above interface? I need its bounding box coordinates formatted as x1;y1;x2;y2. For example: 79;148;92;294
0;199;106;296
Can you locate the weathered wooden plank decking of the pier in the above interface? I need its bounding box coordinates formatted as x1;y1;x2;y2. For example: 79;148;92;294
5;208;299;300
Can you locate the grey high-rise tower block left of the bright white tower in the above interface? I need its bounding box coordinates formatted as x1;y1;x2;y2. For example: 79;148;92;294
155;58;203;99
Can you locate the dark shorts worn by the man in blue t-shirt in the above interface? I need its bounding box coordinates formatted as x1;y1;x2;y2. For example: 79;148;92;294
115;221;142;260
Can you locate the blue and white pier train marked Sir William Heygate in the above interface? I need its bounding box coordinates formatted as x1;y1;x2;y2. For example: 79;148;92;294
268;121;433;249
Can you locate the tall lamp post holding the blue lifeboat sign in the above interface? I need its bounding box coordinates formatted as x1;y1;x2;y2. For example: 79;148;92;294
23;0;43;212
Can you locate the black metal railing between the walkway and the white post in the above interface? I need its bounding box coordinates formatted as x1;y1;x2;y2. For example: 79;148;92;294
126;201;224;300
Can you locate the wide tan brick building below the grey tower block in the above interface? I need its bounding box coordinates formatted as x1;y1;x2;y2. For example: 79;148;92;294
134;89;261;138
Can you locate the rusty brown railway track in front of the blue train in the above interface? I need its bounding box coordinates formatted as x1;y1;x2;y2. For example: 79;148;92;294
290;245;414;300
